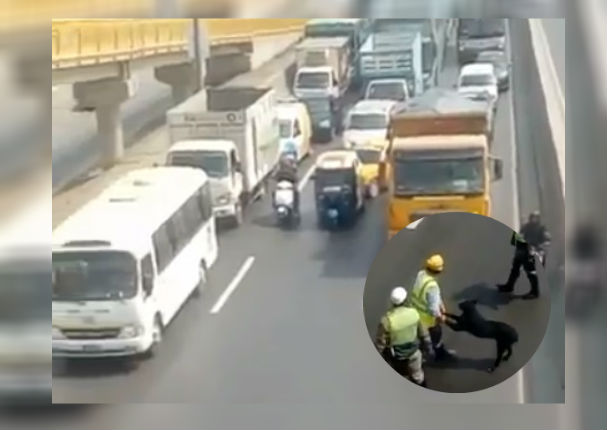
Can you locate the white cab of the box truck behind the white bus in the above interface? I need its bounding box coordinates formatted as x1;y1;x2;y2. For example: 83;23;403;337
166;139;243;224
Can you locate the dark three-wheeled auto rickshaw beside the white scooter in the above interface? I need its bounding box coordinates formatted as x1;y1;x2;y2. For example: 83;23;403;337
314;150;365;228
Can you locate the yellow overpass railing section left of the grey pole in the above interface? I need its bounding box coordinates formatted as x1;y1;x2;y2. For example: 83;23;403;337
52;19;192;69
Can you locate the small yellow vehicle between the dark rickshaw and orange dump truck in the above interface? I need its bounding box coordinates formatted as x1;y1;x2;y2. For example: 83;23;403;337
353;139;387;198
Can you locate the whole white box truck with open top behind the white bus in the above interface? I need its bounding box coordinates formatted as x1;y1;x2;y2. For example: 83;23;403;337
167;87;279;225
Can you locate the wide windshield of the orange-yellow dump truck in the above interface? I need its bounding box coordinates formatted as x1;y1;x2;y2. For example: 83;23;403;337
394;157;484;195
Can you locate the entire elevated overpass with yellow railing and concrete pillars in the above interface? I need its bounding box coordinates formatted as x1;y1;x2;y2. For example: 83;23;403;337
52;19;305;167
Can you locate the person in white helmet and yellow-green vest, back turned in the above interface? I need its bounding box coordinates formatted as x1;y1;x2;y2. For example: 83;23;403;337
375;287;431;387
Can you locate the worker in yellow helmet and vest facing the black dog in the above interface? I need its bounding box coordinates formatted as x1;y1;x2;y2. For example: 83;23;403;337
410;254;455;360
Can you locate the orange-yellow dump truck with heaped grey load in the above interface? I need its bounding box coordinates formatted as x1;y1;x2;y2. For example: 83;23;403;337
380;89;503;238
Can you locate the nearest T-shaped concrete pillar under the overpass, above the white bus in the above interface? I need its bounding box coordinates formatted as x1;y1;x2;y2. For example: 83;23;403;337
73;79;134;169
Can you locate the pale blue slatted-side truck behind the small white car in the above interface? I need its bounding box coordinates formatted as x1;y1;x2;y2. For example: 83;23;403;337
358;19;424;95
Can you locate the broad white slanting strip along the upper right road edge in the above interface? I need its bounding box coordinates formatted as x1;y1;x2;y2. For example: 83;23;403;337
529;19;566;196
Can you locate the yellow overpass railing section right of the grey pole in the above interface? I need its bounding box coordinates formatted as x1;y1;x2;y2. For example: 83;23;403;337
202;18;307;45
